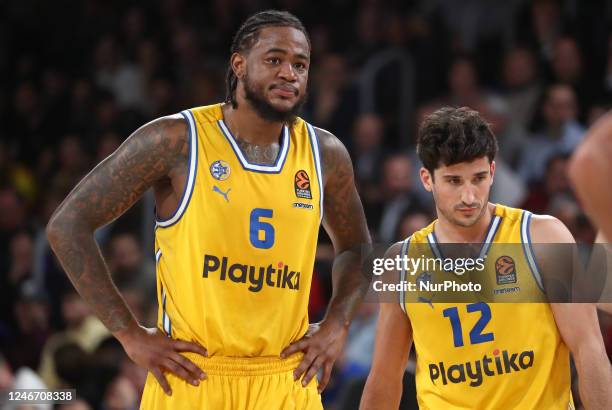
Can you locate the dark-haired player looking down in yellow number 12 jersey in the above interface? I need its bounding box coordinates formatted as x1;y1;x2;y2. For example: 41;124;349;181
361;107;612;410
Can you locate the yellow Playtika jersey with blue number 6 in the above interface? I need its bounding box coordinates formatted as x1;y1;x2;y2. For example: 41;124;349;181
155;104;323;357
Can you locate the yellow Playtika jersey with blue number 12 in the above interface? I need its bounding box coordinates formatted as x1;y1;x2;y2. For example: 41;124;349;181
401;205;573;410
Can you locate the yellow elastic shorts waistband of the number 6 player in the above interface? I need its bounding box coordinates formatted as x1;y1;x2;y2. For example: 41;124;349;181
182;352;304;376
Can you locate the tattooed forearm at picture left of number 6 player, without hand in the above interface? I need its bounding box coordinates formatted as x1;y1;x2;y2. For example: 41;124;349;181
47;215;138;337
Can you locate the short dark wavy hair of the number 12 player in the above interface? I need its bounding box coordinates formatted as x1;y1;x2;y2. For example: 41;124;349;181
417;107;497;175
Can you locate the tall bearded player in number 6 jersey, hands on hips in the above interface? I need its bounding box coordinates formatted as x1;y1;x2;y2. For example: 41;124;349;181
47;10;370;410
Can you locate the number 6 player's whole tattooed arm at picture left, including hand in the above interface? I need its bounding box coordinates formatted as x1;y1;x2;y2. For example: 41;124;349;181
47;116;206;393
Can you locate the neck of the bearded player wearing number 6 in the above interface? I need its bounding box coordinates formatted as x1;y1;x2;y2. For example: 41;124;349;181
221;100;284;145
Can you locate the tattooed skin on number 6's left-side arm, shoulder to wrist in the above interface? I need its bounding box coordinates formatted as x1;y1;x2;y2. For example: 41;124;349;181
48;119;189;332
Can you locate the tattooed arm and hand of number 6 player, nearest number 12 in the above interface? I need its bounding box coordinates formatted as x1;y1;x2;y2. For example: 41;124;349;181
283;128;371;391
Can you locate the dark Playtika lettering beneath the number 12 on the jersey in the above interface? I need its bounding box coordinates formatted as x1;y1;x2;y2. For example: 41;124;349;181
429;349;535;387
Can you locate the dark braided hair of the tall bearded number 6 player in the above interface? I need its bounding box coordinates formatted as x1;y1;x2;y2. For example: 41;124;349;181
225;10;310;108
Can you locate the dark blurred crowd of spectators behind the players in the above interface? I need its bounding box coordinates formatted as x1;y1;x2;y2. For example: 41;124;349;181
0;0;612;410
